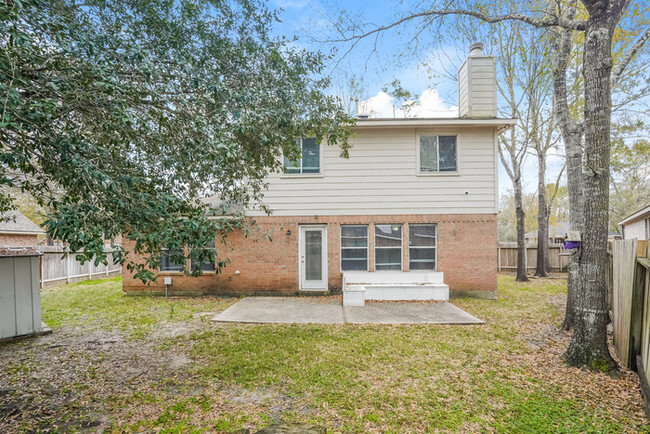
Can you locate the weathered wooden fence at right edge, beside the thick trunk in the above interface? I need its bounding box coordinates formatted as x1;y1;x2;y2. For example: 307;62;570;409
608;239;650;416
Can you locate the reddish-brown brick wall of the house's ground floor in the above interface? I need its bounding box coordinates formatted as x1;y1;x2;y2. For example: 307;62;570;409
123;214;497;297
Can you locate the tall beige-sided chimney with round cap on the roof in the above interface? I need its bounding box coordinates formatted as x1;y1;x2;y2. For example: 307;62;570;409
458;42;497;119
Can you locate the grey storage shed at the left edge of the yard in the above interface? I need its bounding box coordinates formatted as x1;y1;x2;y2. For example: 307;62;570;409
0;248;52;340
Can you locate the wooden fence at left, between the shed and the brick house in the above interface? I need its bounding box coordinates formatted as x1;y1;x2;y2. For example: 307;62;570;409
39;246;122;287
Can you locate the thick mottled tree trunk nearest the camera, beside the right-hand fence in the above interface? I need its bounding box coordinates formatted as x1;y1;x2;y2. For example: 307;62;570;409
565;0;625;371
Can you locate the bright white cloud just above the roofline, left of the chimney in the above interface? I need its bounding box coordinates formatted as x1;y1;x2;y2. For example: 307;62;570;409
359;89;458;118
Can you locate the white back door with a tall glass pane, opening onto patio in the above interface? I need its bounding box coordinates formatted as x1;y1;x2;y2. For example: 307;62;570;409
299;225;327;291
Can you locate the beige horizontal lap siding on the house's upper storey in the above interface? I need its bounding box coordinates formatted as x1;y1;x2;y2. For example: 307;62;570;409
248;127;497;216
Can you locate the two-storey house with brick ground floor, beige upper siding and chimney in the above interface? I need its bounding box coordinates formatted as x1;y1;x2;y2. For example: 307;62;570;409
123;46;516;298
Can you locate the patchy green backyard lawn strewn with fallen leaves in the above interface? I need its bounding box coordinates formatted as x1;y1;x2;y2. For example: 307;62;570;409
0;275;649;432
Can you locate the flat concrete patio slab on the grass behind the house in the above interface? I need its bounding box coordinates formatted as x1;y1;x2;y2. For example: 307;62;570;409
212;297;483;324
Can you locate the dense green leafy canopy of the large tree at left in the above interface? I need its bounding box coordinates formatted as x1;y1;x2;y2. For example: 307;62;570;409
0;0;350;281
